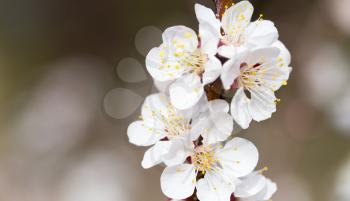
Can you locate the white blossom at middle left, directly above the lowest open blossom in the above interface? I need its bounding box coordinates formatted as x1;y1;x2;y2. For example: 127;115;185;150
127;93;233;168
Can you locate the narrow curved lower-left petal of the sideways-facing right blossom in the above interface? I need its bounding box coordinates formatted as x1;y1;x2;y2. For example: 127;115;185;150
231;88;252;129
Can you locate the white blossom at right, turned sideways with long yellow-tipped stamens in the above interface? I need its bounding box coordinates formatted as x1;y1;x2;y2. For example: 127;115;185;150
221;45;291;129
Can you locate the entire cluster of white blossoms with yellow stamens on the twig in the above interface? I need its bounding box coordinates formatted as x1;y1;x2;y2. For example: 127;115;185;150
127;1;291;201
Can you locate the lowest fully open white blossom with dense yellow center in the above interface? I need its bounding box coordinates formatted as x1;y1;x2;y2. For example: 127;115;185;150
161;137;259;201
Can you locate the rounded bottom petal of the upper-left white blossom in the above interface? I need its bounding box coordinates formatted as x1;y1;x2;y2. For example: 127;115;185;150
169;73;204;110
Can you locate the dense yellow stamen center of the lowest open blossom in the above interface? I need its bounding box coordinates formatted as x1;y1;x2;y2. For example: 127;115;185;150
191;145;218;174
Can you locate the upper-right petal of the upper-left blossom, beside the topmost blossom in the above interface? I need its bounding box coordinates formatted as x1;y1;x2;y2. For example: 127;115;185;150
199;22;221;56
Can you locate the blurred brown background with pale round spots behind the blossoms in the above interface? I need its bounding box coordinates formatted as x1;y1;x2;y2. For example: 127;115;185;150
0;0;350;201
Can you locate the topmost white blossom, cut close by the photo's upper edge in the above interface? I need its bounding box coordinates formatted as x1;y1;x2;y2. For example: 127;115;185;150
195;1;278;58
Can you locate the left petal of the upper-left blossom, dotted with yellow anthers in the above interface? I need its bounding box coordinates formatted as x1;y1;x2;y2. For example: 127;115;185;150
146;45;184;81
